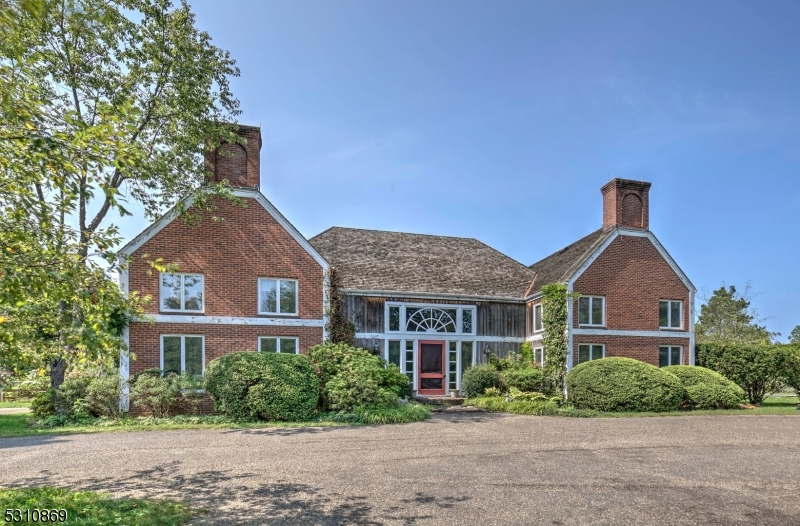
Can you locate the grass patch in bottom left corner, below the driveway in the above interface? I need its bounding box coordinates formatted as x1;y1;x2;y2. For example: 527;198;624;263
0;487;192;526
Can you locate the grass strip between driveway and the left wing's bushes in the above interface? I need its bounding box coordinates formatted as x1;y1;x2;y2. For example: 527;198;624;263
0;403;430;438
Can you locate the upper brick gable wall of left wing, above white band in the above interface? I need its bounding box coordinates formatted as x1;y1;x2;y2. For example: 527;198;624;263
128;198;323;319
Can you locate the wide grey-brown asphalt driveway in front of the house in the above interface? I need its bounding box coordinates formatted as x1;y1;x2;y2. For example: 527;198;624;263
0;413;800;526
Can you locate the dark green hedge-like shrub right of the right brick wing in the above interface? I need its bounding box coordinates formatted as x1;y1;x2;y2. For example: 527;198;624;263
696;343;786;404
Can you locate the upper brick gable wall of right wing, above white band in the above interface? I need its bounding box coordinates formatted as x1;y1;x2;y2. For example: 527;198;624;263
573;236;690;331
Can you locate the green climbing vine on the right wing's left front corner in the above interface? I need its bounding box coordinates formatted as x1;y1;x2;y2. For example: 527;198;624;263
542;283;578;401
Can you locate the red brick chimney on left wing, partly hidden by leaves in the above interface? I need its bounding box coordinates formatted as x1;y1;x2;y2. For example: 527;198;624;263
205;124;261;188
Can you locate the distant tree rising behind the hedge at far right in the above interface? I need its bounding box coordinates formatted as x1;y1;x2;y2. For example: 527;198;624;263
695;283;779;344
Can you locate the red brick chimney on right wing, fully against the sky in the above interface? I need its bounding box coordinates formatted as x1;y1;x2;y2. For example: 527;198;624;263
600;179;651;230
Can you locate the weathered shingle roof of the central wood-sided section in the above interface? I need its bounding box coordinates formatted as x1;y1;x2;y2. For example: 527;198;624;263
309;227;534;299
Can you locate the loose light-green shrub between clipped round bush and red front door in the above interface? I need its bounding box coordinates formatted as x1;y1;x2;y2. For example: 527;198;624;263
308;343;411;411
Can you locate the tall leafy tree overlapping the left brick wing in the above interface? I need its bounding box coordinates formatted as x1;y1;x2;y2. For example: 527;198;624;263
0;0;243;387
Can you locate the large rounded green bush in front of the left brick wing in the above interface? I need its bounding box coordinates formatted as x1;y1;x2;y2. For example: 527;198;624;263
205;351;319;421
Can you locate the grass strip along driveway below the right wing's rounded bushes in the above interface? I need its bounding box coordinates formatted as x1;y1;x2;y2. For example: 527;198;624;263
464;393;800;418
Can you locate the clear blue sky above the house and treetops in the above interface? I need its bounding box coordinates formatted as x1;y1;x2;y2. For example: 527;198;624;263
117;0;800;339
